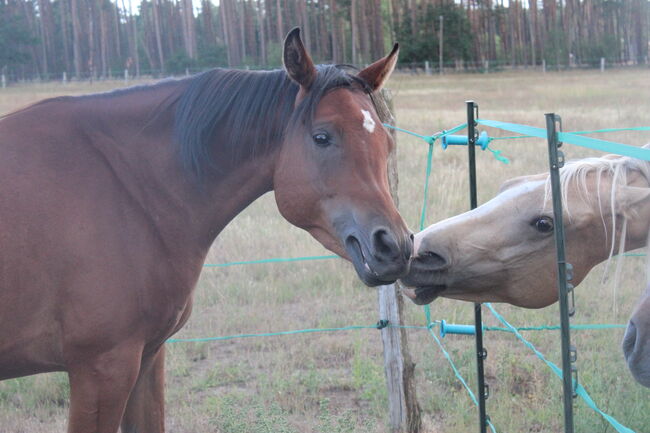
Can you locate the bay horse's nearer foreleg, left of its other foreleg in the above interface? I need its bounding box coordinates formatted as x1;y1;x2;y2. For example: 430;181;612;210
68;346;142;433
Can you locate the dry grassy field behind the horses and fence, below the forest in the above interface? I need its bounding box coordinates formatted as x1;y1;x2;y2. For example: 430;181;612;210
0;69;650;433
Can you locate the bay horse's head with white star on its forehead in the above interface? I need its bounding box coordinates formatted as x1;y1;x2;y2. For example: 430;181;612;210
273;29;412;286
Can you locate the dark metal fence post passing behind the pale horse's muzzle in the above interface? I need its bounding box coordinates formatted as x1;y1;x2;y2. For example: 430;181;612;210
466;101;488;433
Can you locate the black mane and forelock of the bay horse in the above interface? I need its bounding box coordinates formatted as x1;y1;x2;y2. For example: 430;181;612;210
174;65;370;177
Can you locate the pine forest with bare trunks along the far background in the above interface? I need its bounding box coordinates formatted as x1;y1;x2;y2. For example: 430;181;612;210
0;0;650;80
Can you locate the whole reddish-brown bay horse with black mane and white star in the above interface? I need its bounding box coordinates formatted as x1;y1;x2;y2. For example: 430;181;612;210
0;29;412;433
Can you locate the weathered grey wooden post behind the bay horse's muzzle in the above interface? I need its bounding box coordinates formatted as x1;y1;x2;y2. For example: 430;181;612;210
377;90;422;433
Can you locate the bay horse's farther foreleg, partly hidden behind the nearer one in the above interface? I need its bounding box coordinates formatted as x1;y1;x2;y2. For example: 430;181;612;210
122;346;165;433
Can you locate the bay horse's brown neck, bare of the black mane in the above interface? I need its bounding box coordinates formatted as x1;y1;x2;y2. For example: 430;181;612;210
76;81;275;253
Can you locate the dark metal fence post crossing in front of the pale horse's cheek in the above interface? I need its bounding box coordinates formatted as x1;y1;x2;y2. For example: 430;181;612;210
546;113;578;433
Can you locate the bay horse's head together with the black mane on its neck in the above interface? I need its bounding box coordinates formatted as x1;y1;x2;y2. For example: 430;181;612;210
175;29;412;286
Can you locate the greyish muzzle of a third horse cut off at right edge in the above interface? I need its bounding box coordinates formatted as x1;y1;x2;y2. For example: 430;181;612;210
623;286;650;387
